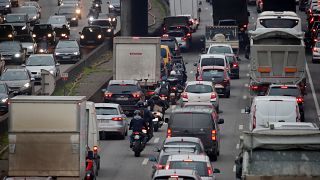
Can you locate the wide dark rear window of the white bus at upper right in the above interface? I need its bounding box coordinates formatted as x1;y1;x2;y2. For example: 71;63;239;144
260;19;299;28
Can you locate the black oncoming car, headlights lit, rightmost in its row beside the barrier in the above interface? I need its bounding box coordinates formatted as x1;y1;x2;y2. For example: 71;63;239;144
79;26;104;46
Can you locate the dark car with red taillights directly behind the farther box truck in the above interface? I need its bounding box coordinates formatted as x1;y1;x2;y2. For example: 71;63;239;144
102;80;145;114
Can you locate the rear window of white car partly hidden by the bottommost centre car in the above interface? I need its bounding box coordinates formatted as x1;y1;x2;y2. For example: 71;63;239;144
169;161;209;176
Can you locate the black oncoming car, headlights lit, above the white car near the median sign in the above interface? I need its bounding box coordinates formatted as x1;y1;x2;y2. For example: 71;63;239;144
32;24;56;44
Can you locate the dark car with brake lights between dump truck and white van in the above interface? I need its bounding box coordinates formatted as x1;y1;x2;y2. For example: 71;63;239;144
266;84;304;121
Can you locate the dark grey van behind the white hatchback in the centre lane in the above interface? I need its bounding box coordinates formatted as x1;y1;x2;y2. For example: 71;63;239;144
165;107;224;161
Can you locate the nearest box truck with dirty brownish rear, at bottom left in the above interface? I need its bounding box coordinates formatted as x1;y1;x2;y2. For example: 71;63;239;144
6;96;100;180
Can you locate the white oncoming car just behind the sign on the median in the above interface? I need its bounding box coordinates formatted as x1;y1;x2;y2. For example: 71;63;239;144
23;54;60;84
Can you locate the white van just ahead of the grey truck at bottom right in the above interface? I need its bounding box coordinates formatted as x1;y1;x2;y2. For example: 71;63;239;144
246;96;300;131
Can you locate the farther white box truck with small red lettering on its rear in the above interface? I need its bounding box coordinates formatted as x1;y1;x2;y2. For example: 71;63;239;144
113;37;162;91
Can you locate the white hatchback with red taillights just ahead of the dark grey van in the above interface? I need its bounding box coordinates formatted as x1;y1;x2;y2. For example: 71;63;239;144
181;81;219;111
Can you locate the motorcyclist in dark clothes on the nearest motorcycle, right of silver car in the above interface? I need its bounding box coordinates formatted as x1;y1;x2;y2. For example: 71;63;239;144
129;110;148;148
